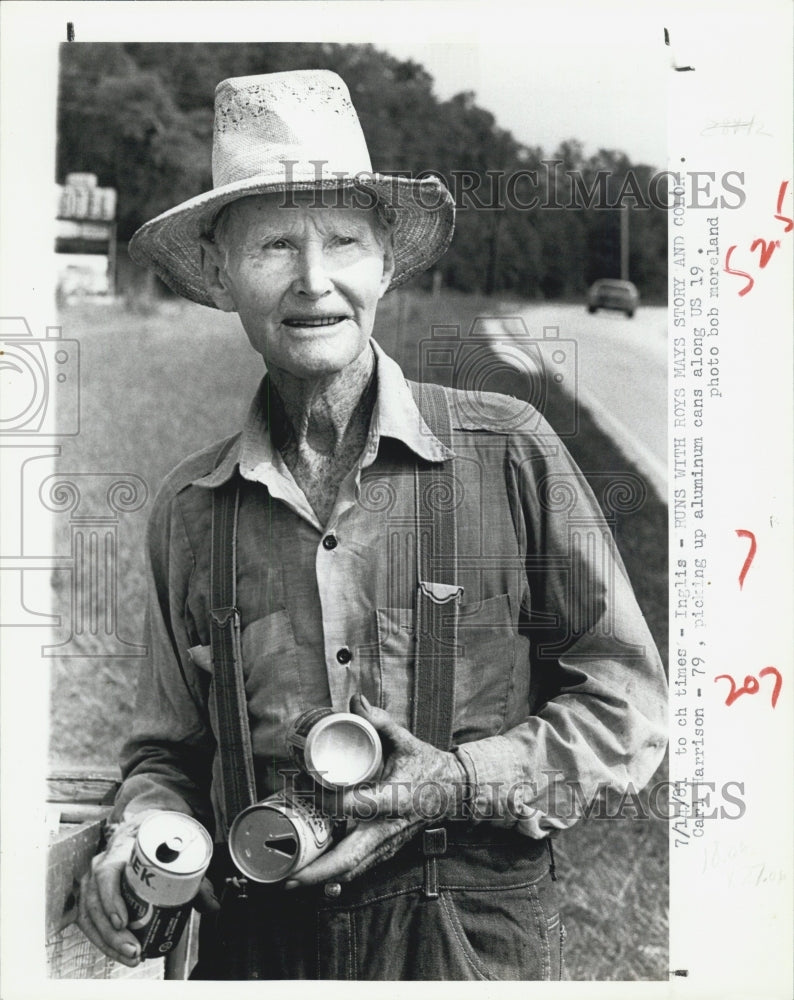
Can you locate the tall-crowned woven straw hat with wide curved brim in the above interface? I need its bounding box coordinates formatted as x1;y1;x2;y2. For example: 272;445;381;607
129;70;455;307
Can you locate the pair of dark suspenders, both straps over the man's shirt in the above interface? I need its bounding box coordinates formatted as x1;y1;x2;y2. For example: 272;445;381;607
210;383;462;824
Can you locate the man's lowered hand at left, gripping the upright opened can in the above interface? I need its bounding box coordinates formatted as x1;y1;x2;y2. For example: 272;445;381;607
77;813;219;969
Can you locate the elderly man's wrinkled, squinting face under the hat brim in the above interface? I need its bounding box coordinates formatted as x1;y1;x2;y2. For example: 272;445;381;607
204;193;393;378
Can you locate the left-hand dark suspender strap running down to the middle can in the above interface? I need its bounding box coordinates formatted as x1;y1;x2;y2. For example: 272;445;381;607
210;476;256;832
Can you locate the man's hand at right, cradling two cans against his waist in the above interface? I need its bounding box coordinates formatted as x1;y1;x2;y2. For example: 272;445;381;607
286;695;466;889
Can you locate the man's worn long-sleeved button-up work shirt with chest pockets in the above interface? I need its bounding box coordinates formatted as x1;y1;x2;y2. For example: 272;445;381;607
114;343;666;837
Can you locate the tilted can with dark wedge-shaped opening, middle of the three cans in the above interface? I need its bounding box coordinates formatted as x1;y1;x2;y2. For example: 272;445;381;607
229;792;334;882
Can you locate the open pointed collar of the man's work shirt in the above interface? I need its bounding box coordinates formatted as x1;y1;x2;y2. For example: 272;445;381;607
193;340;455;489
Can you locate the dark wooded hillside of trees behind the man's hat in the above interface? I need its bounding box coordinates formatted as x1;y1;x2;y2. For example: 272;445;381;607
57;42;667;298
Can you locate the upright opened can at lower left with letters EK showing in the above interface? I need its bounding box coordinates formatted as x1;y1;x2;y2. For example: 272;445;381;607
121;812;212;958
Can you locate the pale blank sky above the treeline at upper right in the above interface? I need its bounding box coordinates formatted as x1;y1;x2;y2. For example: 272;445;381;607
377;30;670;169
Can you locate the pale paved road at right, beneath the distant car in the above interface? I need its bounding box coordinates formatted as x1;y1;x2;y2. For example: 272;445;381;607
486;304;667;500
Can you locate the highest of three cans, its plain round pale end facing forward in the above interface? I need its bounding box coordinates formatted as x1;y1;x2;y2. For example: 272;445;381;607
287;708;383;788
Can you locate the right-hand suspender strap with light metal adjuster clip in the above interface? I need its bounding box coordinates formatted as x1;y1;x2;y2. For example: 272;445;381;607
409;383;463;750
